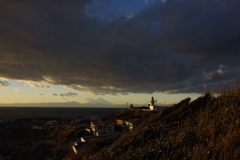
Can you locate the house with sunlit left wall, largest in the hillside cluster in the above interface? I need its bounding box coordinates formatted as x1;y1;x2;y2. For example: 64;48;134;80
91;122;115;136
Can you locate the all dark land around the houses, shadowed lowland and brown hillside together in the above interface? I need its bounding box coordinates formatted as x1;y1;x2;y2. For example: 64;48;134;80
0;88;240;160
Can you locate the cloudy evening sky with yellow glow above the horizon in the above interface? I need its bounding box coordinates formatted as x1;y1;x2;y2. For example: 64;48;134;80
0;0;240;104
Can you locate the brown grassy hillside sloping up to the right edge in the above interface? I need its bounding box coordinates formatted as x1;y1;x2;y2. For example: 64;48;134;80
75;88;240;160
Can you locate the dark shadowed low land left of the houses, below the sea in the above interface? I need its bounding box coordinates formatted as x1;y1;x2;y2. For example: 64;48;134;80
0;119;88;160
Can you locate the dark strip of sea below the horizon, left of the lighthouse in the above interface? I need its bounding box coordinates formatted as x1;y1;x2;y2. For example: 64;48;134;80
0;107;122;121
